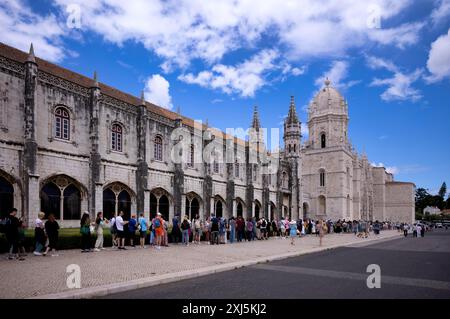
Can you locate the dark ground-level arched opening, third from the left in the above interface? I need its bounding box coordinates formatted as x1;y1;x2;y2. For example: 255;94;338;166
103;182;134;220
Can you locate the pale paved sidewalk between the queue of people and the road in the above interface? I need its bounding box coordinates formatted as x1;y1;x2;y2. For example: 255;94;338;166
0;231;401;298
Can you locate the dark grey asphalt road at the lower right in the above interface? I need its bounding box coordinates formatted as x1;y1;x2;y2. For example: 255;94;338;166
102;230;450;299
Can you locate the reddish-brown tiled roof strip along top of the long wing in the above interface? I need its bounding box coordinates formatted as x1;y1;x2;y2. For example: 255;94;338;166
0;42;250;146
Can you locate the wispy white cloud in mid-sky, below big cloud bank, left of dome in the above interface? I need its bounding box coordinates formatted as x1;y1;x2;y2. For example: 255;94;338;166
178;49;279;97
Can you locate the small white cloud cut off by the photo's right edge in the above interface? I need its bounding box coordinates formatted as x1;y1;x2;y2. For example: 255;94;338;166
426;29;450;82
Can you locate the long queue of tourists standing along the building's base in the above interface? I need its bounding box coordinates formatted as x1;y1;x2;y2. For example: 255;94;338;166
0;209;416;260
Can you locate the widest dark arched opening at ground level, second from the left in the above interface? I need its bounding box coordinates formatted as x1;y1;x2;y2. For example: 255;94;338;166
39;175;84;220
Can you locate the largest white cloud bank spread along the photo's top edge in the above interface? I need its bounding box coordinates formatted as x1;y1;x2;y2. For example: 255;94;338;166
54;0;423;70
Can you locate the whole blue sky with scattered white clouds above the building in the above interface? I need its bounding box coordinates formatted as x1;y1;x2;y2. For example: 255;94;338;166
0;0;450;192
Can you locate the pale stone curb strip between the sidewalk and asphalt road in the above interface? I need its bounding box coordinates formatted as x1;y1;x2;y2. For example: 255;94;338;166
30;233;400;299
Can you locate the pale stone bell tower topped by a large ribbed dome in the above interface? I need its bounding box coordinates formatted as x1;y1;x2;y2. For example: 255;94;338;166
302;78;354;220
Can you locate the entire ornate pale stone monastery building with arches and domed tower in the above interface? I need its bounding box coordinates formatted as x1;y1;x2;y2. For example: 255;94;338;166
0;44;414;227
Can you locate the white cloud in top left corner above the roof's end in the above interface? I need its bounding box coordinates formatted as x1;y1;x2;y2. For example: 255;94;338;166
0;0;67;62
